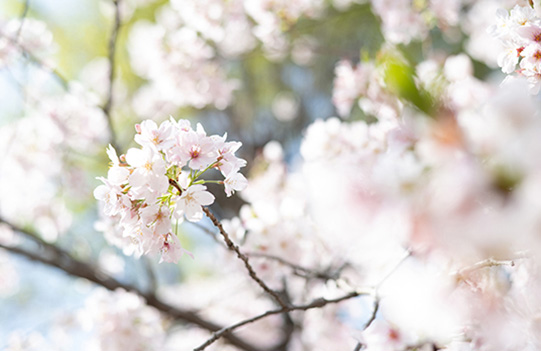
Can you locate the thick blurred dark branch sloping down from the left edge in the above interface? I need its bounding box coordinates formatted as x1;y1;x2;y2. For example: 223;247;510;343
0;218;262;351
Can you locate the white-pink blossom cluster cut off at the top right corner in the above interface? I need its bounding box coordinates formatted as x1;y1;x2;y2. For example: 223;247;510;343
490;4;541;94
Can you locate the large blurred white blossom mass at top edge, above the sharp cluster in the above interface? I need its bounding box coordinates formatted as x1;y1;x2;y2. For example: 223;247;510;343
128;0;324;116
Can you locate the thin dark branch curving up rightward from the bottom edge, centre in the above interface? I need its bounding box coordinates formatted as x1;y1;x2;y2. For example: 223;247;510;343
194;291;370;351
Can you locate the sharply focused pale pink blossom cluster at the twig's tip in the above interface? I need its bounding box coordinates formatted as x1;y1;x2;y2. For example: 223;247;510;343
94;118;247;262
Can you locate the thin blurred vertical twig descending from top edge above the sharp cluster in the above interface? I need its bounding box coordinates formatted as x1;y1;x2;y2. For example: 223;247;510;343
102;0;120;150
